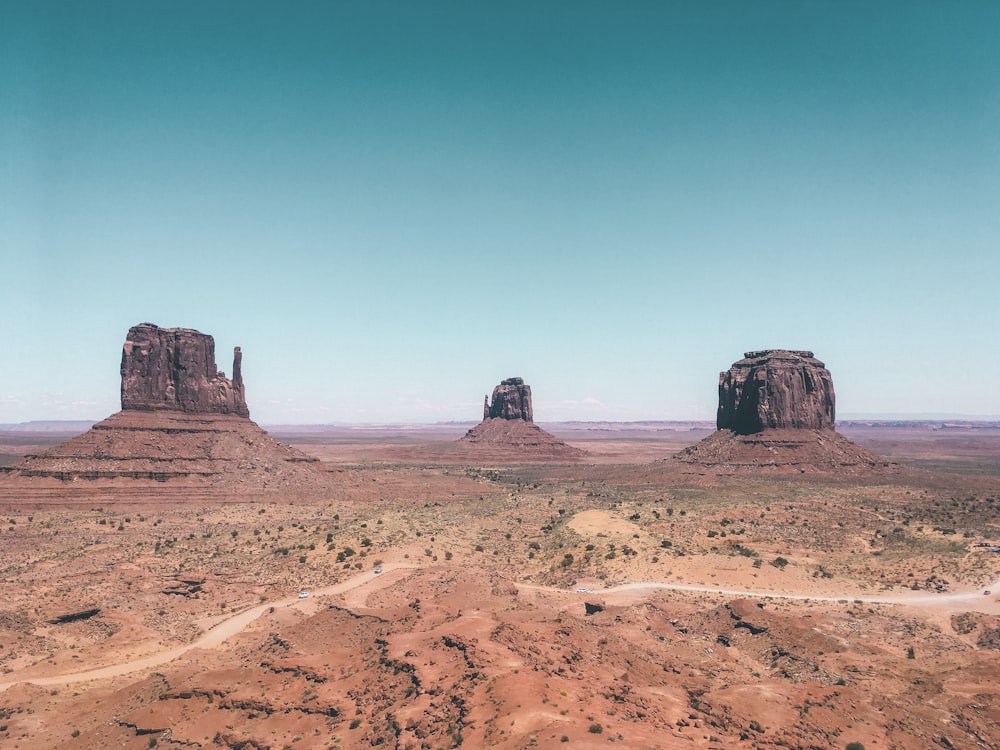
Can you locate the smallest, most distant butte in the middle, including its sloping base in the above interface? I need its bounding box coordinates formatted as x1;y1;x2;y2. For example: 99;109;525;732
458;378;586;461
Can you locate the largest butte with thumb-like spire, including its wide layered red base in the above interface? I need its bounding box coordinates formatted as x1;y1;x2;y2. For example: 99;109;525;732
0;323;329;505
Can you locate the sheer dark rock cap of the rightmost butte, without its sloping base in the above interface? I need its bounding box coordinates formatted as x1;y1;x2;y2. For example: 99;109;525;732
716;349;836;435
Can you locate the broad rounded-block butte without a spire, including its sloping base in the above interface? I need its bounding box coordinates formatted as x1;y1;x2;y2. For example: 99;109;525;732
675;349;891;474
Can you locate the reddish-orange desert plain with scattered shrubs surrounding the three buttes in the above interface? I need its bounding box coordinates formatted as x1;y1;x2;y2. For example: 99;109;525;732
0;422;1000;750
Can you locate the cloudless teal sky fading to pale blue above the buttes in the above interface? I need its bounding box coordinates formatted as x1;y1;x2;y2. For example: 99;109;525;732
0;0;1000;424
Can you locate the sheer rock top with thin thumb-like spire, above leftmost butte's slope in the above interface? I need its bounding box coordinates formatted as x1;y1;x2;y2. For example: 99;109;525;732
121;323;250;418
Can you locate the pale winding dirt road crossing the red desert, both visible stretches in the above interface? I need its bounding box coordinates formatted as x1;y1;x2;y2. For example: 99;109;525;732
0;563;1000;693
